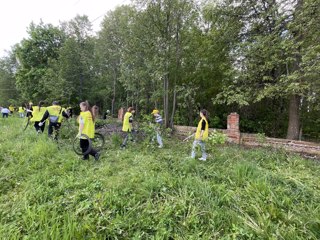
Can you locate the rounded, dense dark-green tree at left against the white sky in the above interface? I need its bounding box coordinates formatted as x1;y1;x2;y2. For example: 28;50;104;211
15;22;64;101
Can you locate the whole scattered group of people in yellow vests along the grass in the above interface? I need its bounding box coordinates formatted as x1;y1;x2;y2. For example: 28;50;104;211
1;101;209;161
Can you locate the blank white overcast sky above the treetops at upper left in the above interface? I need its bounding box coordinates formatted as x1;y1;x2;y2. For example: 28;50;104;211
0;0;130;57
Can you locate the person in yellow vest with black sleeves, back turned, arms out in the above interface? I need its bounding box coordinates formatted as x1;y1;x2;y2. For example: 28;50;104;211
38;101;69;139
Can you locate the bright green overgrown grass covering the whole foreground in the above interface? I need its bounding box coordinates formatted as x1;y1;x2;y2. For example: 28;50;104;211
0;118;320;240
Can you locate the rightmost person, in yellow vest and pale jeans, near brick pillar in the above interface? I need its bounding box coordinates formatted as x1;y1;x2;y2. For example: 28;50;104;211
191;109;209;161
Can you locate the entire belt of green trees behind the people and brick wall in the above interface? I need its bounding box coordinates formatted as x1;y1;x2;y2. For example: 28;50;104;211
0;0;320;141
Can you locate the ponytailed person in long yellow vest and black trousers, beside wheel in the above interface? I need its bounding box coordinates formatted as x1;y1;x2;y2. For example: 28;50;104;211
78;101;100;160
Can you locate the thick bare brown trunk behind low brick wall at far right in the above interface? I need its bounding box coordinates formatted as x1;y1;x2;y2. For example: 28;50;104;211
287;95;300;140
